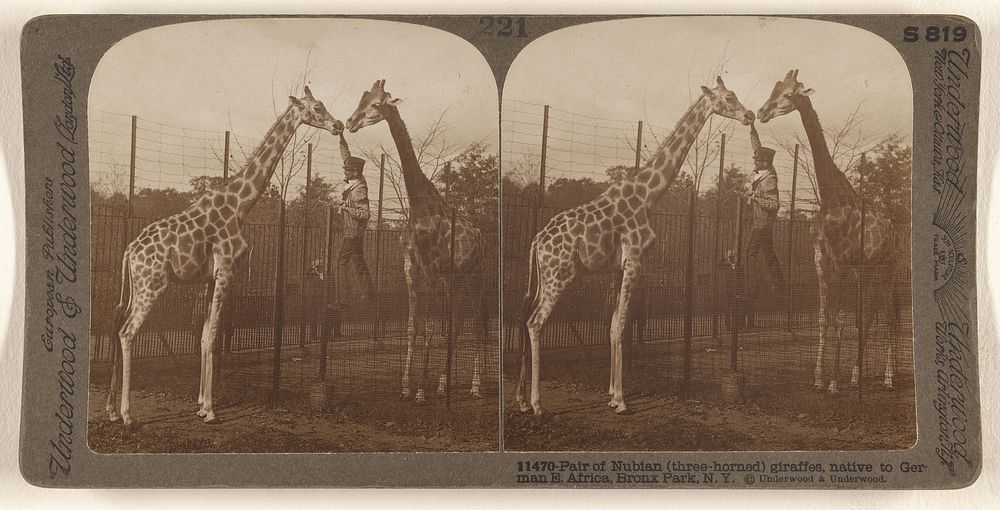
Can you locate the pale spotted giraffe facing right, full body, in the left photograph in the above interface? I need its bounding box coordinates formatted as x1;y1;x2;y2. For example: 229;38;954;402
105;87;344;427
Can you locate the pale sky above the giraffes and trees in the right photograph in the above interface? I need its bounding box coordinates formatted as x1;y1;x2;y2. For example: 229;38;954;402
501;17;913;207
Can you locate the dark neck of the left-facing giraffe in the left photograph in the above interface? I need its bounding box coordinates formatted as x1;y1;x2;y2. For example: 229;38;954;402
383;105;448;221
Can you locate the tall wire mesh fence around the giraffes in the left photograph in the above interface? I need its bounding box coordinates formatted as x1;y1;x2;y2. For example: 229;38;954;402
91;112;499;421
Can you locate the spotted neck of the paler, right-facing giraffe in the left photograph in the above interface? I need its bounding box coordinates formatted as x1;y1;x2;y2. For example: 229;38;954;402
226;106;300;216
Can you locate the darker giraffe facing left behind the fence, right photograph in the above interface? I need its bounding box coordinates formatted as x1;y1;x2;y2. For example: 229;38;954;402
758;69;910;394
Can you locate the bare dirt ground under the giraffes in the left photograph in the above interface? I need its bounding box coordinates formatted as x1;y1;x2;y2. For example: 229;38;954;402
87;336;499;453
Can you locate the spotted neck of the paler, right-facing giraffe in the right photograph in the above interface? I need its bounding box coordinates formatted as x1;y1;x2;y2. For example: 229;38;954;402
635;95;712;206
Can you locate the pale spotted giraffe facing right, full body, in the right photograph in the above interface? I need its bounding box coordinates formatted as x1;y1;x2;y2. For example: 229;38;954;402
516;77;754;415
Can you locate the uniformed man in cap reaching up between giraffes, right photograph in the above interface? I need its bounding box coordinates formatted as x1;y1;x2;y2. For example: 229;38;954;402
747;122;785;295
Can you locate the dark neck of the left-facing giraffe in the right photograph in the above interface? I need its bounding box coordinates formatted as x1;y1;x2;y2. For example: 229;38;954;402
795;96;858;209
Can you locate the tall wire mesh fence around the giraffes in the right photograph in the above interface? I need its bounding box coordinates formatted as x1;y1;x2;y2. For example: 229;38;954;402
501;100;913;402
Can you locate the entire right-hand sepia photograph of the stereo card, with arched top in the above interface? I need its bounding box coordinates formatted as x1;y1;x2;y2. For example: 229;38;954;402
500;16;916;451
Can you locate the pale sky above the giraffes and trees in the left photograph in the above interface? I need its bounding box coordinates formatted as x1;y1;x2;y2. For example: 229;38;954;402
89;19;498;208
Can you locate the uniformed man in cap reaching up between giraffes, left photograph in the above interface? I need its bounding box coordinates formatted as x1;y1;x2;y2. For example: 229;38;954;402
337;134;373;300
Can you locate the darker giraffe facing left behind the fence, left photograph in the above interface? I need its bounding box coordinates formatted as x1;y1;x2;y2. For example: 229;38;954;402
346;80;496;402
